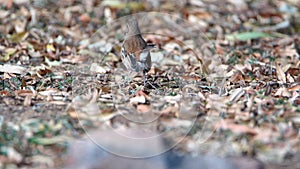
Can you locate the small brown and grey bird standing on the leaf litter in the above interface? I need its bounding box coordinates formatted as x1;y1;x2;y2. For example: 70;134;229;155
121;18;155;86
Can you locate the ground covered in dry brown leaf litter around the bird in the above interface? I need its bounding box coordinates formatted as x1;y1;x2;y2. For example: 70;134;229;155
0;0;300;168
